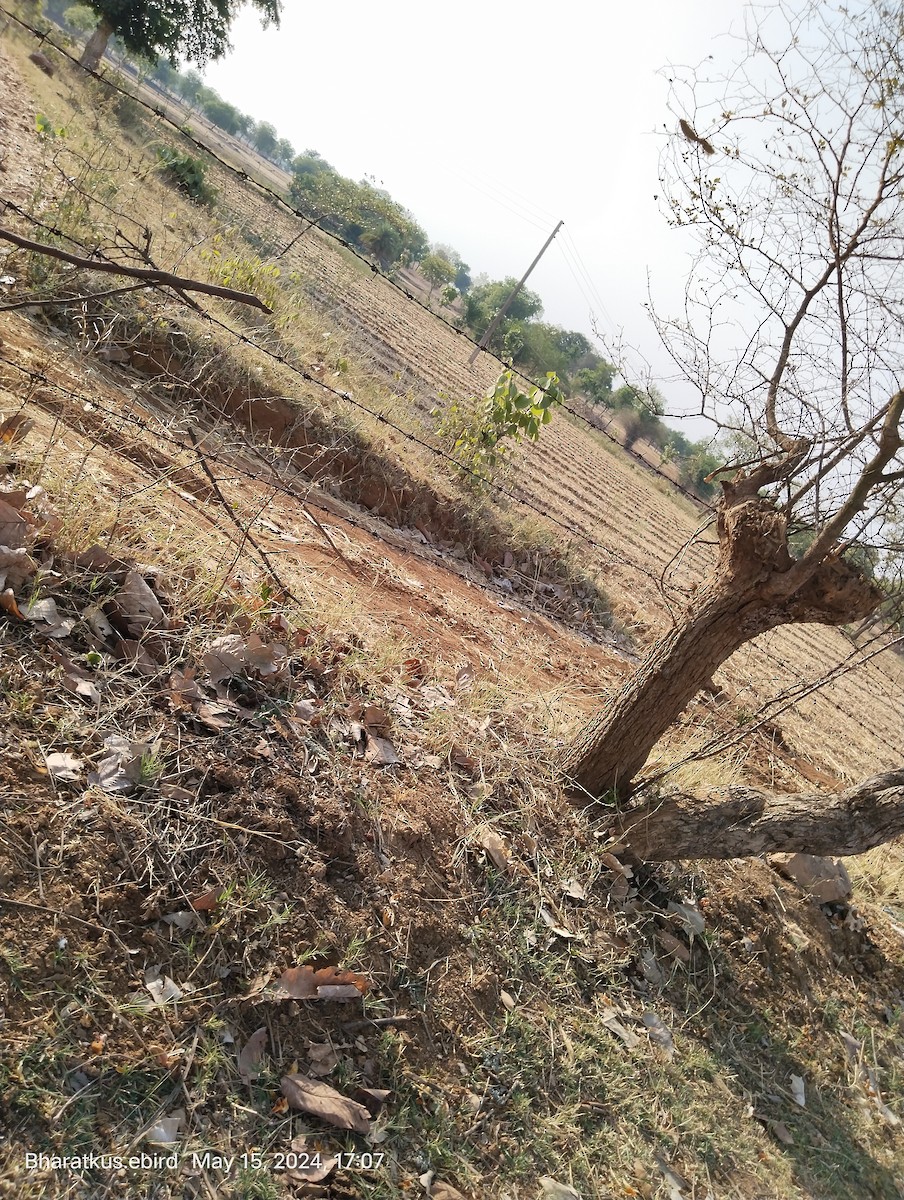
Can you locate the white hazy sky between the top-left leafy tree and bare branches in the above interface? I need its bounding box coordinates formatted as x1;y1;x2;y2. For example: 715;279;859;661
205;0;744;408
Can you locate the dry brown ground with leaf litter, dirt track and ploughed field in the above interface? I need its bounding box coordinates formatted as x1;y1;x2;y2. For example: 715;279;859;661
0;23;904;1200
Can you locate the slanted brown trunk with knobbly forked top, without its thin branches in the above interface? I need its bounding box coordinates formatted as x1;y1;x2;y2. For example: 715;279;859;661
559;488;881;796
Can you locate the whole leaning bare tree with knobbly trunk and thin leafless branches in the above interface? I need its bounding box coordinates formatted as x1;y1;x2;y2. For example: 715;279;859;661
561;0;904;825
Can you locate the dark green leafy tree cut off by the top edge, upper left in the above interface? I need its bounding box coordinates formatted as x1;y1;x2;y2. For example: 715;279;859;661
80;0;282;71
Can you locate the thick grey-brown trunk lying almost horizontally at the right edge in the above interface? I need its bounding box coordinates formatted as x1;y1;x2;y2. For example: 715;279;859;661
612;769;904;863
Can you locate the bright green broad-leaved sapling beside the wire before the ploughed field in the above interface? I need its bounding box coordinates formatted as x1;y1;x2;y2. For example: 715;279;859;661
432;371;564;482
